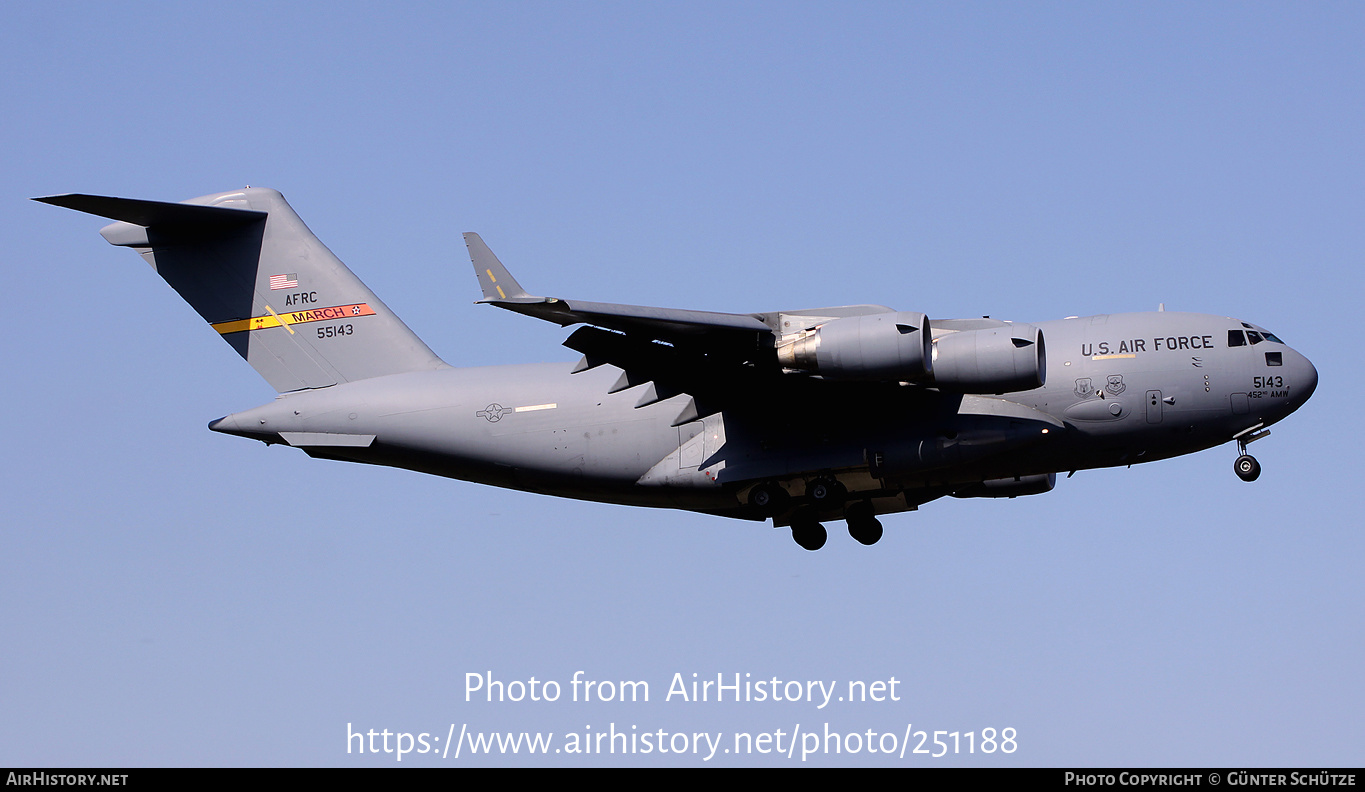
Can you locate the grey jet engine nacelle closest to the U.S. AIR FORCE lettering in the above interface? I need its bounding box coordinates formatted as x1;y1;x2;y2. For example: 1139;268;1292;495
931;324;1047;393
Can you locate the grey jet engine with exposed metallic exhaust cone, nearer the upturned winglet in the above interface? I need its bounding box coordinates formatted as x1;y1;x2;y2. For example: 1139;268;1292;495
777;311;934;381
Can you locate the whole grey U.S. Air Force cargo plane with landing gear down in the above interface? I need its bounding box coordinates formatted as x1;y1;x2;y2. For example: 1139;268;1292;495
38;187;1317;550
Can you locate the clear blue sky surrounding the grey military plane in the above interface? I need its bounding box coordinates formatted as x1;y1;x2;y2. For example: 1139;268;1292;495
0;3;1365;767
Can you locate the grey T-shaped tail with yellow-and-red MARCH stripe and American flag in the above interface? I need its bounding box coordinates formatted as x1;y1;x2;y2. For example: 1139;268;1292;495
35;187;445;393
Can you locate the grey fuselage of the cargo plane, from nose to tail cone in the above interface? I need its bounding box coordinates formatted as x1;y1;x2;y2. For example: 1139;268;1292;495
210;311;1317;518
